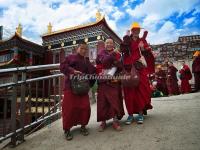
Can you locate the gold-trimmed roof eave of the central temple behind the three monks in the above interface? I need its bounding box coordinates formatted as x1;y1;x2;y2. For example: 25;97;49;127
42;16;122;41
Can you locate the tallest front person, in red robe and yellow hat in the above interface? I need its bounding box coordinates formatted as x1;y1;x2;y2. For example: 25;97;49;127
120;22;154;125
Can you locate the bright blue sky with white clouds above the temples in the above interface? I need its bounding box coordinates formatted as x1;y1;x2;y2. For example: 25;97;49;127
0;0;200;44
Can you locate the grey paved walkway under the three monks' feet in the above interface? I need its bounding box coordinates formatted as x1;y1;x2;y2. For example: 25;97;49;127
2;93;200;150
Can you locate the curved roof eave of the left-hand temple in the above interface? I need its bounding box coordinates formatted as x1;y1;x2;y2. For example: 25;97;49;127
0;32;44;56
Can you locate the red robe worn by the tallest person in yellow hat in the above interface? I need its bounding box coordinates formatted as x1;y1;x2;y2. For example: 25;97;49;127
122;38;154;115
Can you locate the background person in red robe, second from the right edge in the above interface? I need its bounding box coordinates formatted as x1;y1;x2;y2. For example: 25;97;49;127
179;61;192;93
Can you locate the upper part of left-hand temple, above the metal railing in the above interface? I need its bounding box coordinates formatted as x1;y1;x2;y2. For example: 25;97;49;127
0;24;45;84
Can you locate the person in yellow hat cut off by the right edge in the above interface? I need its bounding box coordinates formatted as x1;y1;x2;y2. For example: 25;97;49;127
192;51;200;91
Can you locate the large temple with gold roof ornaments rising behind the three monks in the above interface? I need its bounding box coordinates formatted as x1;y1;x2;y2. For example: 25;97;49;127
42;11;121;63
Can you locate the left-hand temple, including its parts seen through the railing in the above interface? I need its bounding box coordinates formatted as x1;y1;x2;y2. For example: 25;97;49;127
0;24;45;136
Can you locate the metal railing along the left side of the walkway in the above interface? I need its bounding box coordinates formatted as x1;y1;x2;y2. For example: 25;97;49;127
0;64;63;146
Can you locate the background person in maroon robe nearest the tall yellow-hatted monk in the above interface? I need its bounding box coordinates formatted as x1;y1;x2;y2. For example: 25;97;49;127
155;66;168;96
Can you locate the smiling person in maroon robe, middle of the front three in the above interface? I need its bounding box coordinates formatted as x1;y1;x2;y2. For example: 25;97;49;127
96;39;124;132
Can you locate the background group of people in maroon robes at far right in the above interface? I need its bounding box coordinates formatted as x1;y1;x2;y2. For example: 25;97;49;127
150;54;200;97
